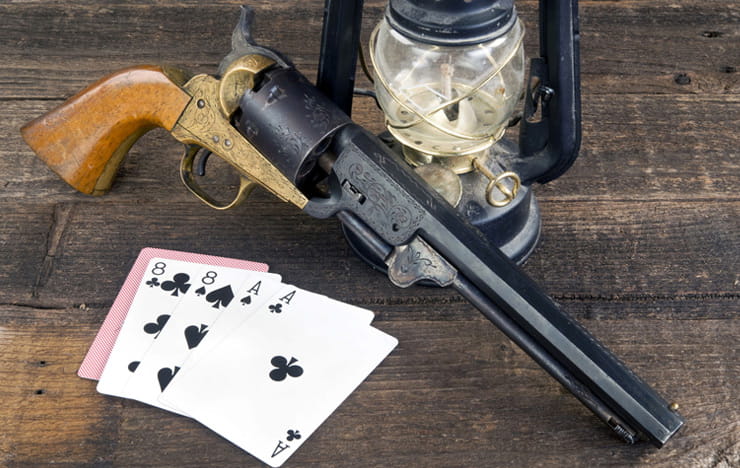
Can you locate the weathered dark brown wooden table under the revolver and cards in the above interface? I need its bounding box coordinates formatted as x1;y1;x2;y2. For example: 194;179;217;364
0;0;740;467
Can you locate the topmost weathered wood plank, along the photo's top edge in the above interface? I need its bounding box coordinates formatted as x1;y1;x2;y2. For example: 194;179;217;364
0;0;740;98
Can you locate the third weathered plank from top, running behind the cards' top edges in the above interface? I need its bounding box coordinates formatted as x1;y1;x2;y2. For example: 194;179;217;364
0;194;740;316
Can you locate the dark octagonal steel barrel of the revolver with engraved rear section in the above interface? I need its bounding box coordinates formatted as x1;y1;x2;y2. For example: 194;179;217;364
316;126;683;446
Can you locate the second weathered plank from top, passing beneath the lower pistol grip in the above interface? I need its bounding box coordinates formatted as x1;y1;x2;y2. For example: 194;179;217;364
0;94;740;203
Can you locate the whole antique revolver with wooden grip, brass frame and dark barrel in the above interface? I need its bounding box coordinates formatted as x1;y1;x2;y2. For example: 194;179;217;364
22;7;684;447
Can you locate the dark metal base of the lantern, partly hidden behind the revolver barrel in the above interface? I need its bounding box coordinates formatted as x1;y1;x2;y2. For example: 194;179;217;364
342;138;541;272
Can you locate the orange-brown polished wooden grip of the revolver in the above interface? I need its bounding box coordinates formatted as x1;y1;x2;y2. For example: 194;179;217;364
21;66;190;195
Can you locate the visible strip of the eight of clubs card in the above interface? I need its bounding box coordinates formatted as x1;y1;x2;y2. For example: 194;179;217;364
97;258;205;395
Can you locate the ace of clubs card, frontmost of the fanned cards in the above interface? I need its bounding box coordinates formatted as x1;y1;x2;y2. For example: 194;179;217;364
161;292;398;467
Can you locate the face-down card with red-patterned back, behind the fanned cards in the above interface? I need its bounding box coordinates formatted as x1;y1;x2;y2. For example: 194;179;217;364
77;247;268;380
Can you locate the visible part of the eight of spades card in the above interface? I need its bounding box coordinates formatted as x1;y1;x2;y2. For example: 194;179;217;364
120;266;280;413
